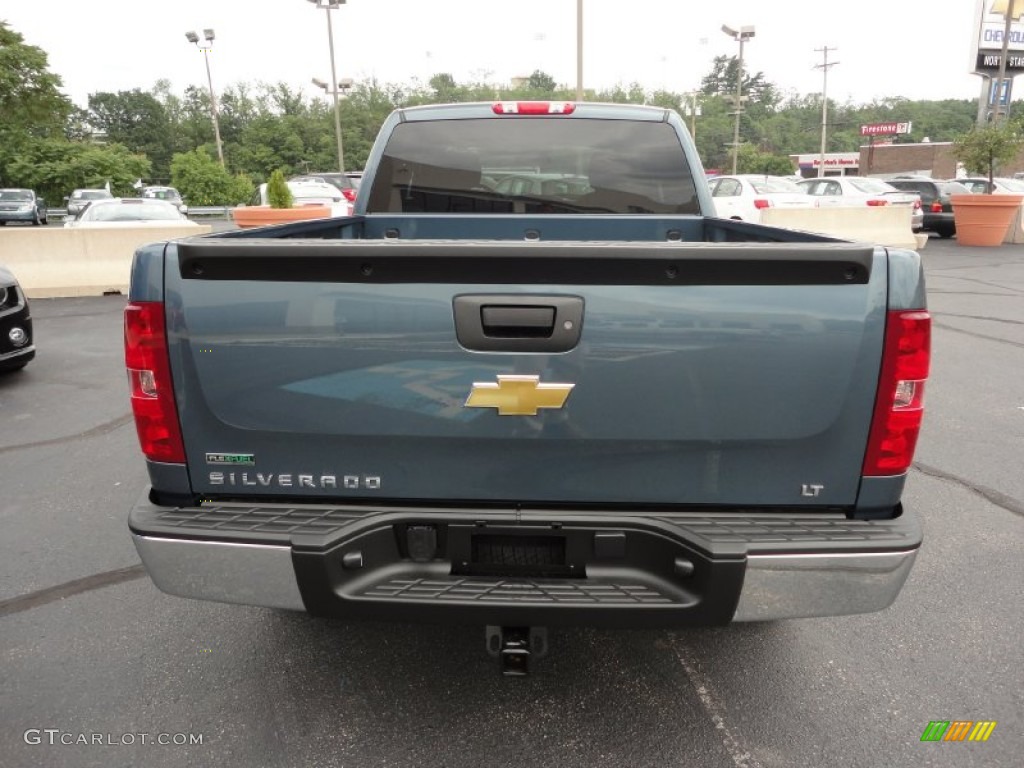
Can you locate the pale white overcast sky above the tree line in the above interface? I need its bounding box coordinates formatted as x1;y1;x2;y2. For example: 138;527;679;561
0;0;991;106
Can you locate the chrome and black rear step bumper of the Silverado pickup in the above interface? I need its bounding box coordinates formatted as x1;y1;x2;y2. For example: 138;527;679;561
131;501;921;627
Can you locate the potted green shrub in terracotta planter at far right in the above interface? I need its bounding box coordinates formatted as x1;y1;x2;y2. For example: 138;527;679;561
950;123;1024;246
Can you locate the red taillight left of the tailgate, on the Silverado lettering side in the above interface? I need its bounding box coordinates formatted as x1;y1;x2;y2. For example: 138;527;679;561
125;301;185;464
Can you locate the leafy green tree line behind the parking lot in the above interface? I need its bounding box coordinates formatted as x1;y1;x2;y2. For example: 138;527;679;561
0;22;976;205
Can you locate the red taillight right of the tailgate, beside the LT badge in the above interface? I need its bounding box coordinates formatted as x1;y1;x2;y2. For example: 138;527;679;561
863;310;932;476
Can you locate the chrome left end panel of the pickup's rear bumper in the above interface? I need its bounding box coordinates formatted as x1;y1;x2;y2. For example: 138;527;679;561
132;534;305;610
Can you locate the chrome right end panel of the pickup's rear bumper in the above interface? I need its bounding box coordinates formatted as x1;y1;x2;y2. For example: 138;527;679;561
733;549;918;622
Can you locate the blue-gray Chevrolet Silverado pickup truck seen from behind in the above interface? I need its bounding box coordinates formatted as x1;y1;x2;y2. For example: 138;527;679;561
125;102;930;672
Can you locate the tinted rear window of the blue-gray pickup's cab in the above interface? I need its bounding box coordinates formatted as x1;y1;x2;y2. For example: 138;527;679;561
367;117;699;214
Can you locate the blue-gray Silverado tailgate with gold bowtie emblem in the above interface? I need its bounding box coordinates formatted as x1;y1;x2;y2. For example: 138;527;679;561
165;239;887;507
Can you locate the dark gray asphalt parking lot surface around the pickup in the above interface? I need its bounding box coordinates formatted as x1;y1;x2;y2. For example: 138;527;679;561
0;239;1024;768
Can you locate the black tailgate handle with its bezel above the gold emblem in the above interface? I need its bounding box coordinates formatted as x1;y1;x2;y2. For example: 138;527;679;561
452;294;584;352
